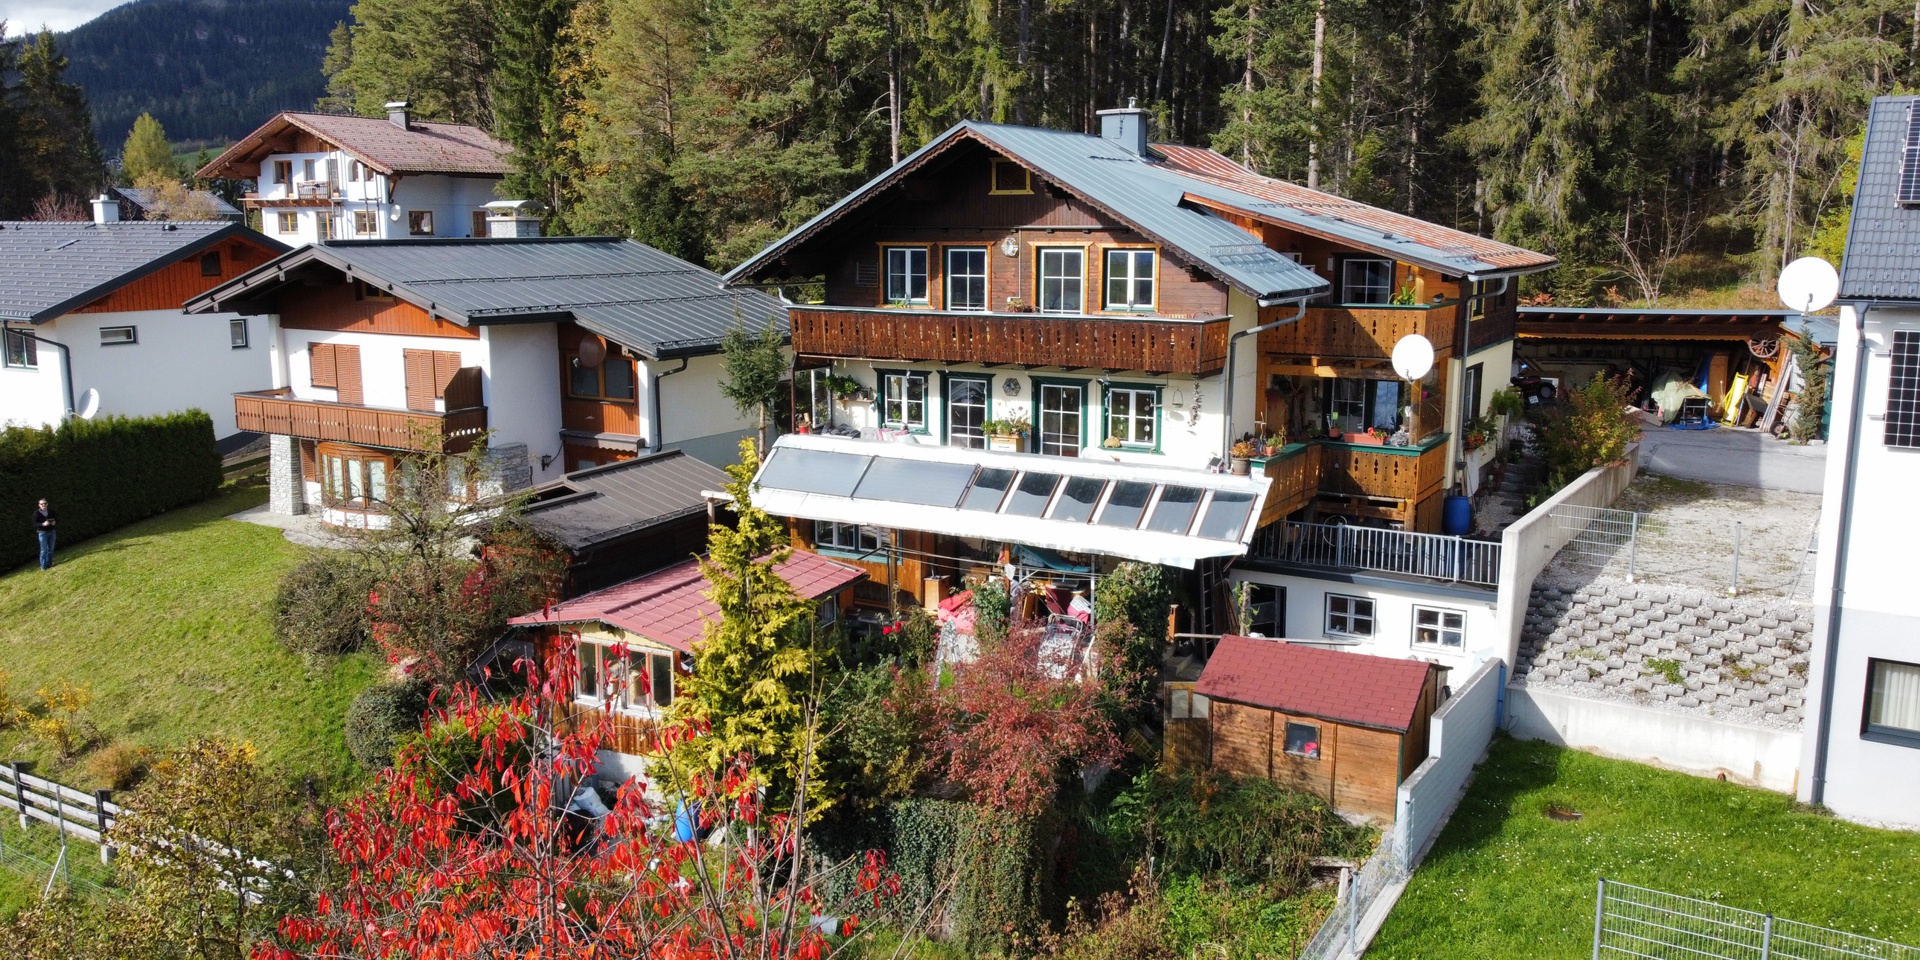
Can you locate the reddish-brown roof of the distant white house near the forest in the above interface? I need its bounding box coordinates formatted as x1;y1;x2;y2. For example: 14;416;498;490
198;111;513;177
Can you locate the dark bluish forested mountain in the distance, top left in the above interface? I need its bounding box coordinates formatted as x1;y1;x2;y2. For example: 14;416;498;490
60;0;353;154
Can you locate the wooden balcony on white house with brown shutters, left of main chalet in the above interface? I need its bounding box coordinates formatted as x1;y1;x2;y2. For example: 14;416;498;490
234;388;486;453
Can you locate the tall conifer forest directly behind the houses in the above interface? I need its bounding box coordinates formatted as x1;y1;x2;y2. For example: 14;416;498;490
314;0;1920;301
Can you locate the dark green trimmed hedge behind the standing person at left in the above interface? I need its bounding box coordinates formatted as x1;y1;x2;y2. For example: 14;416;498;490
0;411;221;570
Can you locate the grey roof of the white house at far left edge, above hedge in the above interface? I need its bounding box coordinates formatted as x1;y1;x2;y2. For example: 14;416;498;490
0;221;286;323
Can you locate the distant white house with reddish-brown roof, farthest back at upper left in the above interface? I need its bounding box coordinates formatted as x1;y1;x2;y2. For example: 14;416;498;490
198;102;511;246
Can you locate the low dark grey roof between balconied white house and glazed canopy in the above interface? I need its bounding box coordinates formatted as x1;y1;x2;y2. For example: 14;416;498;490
526;449;728;551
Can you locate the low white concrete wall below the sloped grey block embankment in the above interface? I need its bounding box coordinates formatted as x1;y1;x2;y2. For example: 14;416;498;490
1507;685;1801;793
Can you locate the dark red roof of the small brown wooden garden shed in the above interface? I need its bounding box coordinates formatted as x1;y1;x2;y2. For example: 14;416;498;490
1194;636;1432;733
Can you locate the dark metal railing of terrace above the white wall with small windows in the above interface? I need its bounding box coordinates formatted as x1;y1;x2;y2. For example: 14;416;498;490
1246;520;1500;586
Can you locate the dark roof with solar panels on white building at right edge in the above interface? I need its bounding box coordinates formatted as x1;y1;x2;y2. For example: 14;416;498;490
1839;96;1920;300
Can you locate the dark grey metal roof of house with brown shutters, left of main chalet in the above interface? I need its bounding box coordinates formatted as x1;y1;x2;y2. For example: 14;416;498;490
188;236;787;359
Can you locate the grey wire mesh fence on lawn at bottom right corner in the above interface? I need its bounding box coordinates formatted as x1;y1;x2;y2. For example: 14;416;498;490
1594;879;1920;960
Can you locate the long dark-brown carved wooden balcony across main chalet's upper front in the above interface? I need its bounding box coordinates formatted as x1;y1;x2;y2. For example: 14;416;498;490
787;307;1227;374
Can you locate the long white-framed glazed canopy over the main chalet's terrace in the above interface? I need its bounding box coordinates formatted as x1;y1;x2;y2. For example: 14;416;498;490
753;434;1267;568
